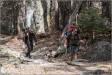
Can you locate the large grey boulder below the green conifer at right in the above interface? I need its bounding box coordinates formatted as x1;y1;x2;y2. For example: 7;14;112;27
83;41;111;61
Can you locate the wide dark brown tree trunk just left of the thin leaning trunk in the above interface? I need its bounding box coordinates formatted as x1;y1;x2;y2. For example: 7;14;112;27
58;0;71;31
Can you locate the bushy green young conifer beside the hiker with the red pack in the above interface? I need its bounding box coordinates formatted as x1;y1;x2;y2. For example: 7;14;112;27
78;8;109;39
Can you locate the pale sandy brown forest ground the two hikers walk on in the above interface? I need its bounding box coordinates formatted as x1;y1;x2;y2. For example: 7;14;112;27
0;35;112;75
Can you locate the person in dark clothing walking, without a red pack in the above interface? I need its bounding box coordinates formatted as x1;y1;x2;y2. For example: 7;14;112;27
23;28;37;58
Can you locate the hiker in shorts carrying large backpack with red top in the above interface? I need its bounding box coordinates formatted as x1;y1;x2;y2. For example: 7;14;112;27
64;24;80;61
